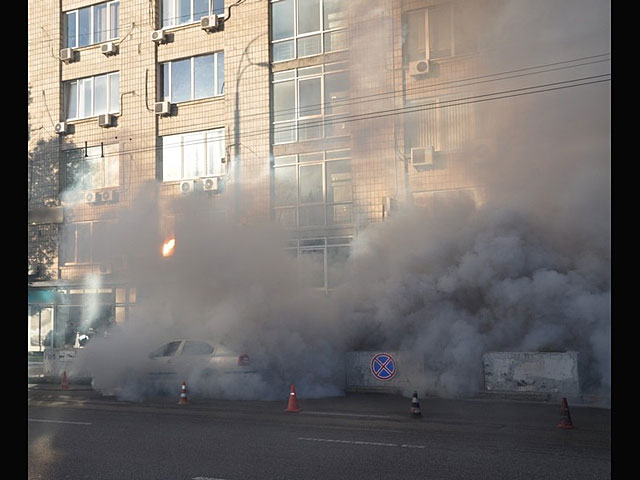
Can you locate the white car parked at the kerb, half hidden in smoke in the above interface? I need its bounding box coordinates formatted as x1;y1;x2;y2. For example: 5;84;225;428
148;339;256;381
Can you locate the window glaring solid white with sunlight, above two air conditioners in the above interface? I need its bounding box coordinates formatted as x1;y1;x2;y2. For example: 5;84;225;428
161;128;225;182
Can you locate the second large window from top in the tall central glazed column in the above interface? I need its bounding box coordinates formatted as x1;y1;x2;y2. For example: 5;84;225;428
273;62;349;144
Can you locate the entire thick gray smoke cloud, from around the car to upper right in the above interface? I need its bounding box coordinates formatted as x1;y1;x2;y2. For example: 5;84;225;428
71;0;611;399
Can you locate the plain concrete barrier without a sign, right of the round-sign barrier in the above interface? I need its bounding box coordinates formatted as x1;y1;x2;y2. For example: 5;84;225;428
482;352;580;395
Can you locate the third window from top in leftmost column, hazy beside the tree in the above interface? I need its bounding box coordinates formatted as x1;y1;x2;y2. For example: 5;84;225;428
62;144;120;190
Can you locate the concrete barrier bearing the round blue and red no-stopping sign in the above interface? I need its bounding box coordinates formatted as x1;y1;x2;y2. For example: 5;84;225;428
345;350;424;396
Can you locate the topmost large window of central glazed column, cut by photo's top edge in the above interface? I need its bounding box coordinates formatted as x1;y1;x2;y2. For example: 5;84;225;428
271;0;347;62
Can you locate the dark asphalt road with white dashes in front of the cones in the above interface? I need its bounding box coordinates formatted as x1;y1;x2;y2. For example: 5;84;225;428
28;387;611;480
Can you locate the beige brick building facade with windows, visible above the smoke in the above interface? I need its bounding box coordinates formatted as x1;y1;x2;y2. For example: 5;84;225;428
28;0;498;351
